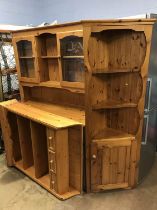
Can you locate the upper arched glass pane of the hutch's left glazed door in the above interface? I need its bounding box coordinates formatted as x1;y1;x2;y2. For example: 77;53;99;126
17;40;32;56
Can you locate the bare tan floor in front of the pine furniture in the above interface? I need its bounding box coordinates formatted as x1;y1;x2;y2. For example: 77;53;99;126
0;155;157;210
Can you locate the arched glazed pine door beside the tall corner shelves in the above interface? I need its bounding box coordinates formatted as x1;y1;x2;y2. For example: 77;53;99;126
57;30;85;89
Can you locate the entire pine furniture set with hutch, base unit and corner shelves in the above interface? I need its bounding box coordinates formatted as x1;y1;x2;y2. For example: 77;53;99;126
0;19;157;200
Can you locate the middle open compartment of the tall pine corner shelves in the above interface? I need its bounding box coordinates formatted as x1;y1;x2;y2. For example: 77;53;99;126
90;72;143;110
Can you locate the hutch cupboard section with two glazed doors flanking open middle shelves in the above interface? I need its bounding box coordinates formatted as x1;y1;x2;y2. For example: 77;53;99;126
15;31;85;90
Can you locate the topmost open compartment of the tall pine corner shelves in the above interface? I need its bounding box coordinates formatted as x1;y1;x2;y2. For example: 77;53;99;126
88;29;146;74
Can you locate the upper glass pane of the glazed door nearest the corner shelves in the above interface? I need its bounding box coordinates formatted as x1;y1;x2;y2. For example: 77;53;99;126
61;36;83;56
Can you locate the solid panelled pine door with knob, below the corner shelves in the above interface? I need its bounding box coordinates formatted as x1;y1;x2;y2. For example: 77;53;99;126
91;141;131;192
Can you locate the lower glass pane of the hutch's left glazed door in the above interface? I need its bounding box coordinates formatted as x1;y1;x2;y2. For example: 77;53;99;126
20;58;35;78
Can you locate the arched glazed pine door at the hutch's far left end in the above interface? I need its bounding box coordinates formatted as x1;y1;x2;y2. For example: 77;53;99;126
13;36;40;83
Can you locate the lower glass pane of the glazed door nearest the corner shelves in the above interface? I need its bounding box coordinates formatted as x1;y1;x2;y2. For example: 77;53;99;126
62;58;84;82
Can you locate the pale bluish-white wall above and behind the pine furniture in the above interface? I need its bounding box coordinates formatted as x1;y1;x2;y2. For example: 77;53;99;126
0;0;157;25
